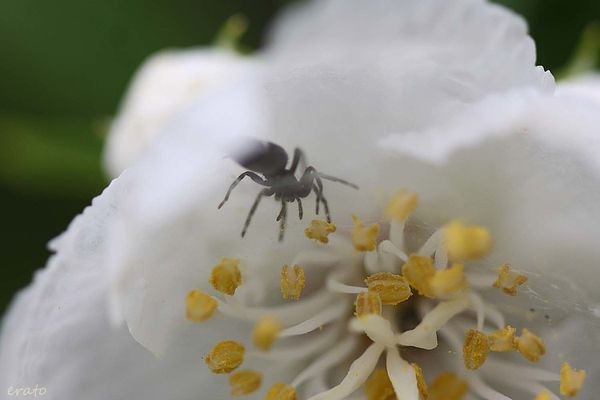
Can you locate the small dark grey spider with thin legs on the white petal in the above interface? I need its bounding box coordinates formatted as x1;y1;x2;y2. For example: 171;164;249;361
217;139;358;241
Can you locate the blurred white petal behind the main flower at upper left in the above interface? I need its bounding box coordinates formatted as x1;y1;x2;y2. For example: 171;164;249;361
105;49;251;177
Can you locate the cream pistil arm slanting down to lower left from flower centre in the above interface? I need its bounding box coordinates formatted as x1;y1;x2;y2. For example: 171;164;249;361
308;343;385;400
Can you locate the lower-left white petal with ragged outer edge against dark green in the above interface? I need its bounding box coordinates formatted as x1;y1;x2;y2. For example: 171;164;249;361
0;182;282;400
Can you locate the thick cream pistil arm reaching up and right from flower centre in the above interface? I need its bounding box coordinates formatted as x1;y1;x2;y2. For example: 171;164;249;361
396;296;469;350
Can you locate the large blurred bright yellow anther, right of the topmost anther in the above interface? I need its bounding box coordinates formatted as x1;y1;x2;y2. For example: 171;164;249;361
443;221;492;260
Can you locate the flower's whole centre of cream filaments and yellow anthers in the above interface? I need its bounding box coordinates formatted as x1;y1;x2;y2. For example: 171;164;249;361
186;190;585;400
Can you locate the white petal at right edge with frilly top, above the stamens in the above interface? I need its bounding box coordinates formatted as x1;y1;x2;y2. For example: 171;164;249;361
381;88;600;318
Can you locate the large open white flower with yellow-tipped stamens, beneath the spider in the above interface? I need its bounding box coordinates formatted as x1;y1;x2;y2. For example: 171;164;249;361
0;0;600;400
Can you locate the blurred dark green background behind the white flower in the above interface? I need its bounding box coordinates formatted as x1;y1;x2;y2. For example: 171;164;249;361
0;0;600;315
